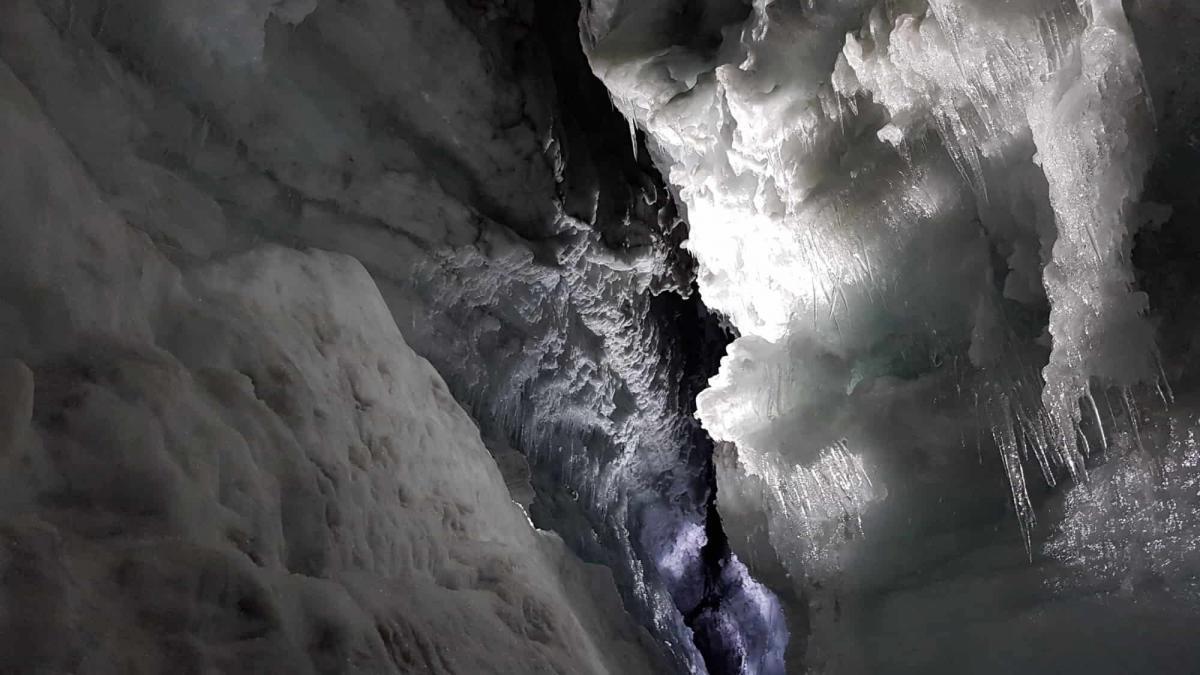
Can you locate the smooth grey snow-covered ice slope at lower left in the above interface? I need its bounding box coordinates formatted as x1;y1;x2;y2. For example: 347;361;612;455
0;55;665;674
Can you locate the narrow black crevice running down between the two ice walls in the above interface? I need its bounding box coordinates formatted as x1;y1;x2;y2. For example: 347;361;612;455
526;0;782;675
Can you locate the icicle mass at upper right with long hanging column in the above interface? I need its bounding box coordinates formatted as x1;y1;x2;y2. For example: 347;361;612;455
839;0;1159;504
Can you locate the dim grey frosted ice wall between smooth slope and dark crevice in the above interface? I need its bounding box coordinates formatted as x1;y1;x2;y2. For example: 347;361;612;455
0;0;786;671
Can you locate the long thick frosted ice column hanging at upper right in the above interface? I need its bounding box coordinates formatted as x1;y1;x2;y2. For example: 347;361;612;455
1030;0;1158;478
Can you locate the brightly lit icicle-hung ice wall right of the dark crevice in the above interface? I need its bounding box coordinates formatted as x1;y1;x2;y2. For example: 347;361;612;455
590;0;1200;673
